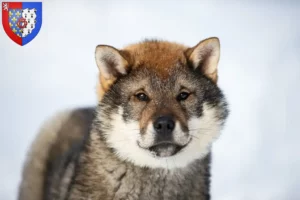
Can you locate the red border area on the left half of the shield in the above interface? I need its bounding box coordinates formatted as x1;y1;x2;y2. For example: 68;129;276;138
2;2;22;46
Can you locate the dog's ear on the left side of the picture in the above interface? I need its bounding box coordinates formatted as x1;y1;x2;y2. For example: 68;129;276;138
95;45;128;100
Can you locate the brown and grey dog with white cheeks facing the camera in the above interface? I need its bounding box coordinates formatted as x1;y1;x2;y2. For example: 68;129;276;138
19;37;229;200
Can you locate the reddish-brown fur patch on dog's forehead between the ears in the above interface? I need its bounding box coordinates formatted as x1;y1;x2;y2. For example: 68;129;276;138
124;40;187;78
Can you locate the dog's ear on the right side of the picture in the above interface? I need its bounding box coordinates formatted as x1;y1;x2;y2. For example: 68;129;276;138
186;37;220;83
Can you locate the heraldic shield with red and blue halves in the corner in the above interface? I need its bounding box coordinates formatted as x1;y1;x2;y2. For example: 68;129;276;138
2;2;42;46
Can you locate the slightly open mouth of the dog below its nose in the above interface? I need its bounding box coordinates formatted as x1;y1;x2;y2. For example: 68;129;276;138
149;142;186;157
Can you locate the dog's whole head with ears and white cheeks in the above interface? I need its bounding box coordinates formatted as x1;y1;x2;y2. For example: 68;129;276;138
96;38;227;168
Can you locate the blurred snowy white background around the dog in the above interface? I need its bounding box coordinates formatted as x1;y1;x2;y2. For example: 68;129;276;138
0;0;300;200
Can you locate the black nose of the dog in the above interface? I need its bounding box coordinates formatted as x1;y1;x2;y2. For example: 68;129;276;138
153;116;175;135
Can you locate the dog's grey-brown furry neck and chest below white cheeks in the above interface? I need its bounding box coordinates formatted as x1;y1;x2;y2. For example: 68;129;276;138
71;130;210;200
